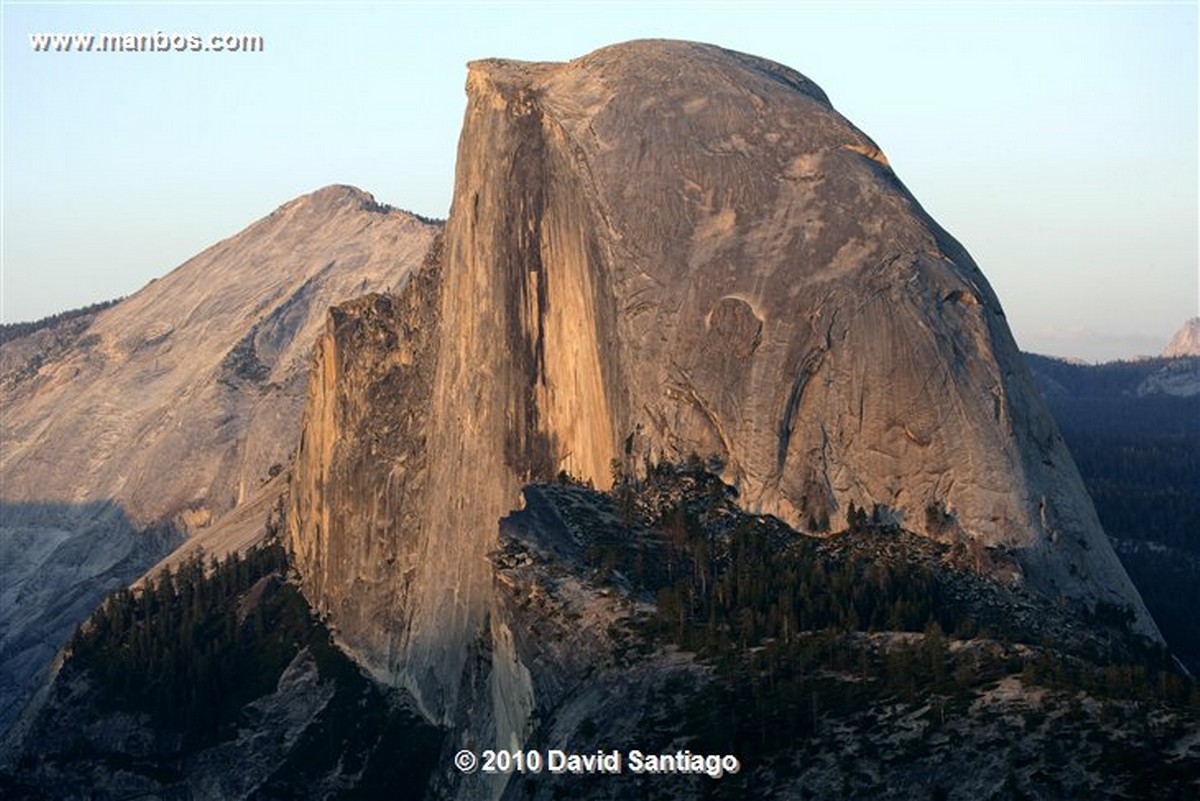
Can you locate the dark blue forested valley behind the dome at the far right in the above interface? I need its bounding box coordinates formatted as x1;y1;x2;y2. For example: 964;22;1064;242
1025;354;1200;674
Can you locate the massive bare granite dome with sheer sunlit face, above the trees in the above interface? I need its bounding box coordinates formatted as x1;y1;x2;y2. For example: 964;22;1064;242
285;41;1157;724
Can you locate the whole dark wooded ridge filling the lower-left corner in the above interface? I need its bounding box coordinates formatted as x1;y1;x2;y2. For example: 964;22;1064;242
0;529;443;801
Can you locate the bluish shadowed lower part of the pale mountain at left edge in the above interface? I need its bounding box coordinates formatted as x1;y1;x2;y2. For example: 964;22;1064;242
0;501;182;733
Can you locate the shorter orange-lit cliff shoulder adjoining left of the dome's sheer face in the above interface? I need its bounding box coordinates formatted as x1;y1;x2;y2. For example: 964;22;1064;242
288;239;452;683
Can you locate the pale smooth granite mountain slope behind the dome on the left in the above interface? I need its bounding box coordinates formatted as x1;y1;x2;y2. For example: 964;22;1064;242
0;186;438;730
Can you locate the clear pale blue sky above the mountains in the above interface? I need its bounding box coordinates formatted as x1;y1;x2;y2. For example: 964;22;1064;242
0;0;1200;360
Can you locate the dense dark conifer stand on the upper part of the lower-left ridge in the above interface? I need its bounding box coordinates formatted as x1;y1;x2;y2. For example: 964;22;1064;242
67;543;297;743
